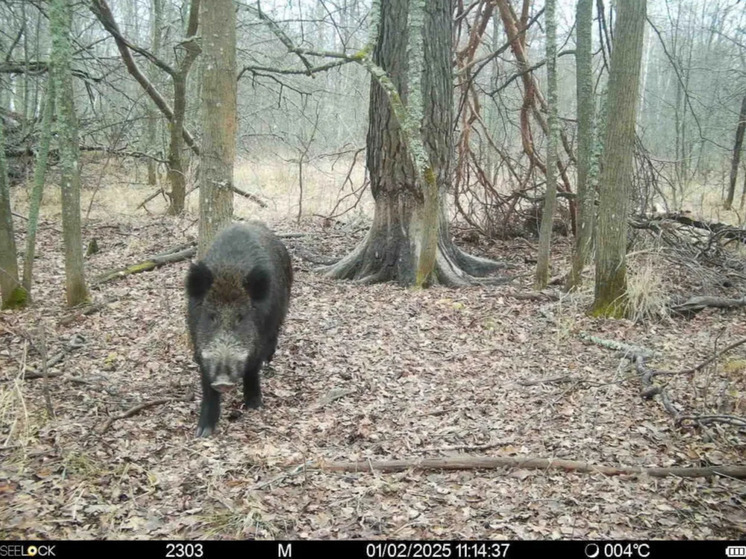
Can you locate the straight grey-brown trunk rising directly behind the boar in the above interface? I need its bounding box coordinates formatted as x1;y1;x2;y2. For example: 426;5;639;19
198;0;236;257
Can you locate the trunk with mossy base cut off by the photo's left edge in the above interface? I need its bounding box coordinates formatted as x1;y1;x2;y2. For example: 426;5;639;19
0;92;26;309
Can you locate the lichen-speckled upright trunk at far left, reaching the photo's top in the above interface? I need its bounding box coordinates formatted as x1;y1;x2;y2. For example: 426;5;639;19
49;0;88;307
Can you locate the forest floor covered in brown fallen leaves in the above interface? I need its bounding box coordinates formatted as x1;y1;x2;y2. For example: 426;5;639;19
0;182;746;539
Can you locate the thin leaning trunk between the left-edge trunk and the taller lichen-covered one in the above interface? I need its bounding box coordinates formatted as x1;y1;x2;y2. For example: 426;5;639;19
23;81;55;296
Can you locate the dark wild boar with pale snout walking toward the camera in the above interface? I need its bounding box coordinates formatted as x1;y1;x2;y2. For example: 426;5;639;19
186;222;293;437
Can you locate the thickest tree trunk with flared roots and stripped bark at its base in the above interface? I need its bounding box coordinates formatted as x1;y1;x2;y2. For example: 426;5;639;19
324;0;500;285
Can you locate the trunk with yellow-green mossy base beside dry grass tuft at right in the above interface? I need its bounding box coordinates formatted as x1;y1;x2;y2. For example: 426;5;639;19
591;0;646;317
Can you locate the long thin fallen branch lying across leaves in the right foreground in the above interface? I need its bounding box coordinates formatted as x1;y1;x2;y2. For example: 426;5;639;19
296;456;746;479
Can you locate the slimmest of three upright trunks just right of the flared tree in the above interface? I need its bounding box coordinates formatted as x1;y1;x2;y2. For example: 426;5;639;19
534;0;559;290
